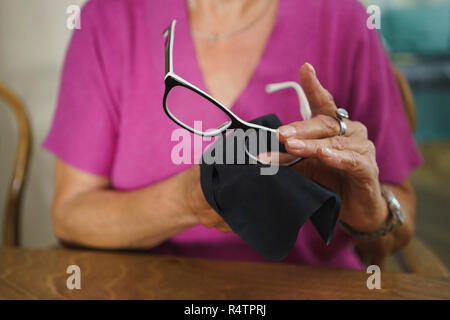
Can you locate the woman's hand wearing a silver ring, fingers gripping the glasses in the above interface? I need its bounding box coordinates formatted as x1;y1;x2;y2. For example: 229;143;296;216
279;64;388;232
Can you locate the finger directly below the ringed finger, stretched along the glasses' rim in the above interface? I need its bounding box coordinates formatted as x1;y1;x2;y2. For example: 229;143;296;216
285;136;375;158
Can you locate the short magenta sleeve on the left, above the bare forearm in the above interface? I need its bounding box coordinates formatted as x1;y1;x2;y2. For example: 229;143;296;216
43;1;118;176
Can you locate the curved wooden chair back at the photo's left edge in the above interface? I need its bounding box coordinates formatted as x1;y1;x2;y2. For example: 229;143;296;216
0;83;31;246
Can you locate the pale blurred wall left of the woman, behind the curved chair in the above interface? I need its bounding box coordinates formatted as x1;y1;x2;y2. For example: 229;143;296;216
0;0;85;247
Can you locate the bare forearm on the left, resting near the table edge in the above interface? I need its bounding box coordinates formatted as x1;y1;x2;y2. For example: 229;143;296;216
52;168;198;249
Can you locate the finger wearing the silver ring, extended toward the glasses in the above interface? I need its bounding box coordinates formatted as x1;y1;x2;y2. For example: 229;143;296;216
278;115;367;143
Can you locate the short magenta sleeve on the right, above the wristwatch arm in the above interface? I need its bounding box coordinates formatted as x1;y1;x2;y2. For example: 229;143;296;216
346;6;422;184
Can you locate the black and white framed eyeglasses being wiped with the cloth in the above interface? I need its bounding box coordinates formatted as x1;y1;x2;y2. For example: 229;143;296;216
163;20;311;166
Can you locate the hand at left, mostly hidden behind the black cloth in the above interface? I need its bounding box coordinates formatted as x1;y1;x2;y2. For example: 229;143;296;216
185;164;232;233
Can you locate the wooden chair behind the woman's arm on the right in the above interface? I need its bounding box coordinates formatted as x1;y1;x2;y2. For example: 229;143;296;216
386;65;449;277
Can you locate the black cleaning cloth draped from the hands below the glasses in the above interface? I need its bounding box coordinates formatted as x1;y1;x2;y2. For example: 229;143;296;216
200;114;341;261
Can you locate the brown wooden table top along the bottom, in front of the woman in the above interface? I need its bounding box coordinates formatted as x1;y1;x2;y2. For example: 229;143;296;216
0;248;450;299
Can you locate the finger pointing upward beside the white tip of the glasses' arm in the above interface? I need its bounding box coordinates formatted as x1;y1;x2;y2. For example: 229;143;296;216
300;63;337;116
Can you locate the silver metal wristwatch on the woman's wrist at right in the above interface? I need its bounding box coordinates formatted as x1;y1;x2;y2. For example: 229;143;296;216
339;186;405;240
